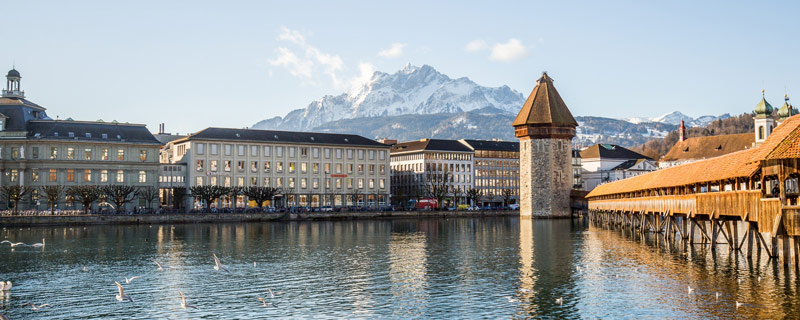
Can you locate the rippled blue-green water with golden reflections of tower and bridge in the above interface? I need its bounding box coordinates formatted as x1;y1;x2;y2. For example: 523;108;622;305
0;217;800;320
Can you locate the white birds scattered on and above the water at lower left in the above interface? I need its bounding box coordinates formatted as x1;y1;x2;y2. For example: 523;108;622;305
0;239;275;320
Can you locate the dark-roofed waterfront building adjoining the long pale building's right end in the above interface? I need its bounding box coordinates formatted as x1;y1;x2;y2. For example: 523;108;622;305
391;139;475;206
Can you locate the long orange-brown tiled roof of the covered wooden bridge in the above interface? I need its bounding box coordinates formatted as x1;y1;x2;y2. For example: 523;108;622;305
587;115;800;198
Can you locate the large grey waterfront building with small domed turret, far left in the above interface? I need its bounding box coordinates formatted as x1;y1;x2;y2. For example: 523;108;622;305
0;69;161;210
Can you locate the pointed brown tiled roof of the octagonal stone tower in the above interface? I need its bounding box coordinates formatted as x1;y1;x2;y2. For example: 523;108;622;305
512;72;578;127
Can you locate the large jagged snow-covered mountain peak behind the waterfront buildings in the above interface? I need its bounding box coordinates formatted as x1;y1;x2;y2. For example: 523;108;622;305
253;64;525;130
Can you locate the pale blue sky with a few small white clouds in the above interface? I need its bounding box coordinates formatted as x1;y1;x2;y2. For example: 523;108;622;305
0;1;800;133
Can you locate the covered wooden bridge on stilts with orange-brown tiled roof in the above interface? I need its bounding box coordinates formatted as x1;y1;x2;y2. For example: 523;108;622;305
587;116;800;265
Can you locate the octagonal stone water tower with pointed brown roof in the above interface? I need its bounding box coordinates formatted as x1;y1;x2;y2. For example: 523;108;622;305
512;72;578;218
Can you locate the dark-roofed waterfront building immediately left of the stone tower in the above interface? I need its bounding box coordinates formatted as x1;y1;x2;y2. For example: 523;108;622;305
458;139;519;206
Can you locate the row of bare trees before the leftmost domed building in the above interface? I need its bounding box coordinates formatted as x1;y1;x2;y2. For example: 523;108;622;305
0;185;158;214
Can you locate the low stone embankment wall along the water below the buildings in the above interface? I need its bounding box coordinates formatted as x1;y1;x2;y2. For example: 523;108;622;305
0;211;519;227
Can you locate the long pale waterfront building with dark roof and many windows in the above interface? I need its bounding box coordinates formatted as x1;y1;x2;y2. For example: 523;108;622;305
161;128;391;207
